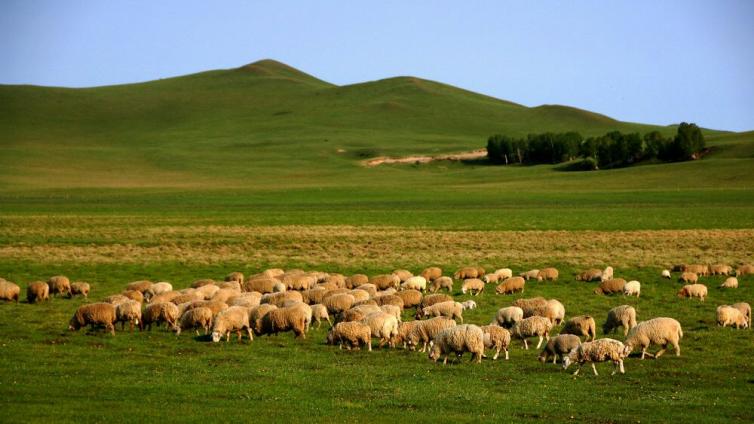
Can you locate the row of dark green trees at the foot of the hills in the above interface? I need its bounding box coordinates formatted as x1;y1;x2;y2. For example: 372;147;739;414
487;122;705;169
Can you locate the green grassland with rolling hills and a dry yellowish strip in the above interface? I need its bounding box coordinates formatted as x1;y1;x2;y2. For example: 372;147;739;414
0;61;754;422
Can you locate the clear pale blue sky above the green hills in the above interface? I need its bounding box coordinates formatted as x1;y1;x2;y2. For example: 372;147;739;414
0;0;754;130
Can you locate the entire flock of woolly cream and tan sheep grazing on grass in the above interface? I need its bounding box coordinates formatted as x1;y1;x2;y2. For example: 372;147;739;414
0;265;754;374
